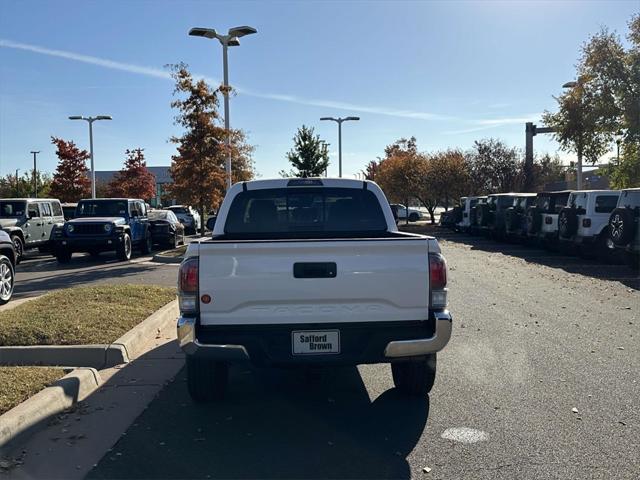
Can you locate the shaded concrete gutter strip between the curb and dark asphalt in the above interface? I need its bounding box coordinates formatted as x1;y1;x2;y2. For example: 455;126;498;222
2;316;184;480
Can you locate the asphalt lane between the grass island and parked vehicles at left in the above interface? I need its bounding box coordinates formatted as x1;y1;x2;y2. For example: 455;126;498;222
14;236;198;300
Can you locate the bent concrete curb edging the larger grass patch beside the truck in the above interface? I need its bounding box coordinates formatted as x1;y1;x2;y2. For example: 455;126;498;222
0;300;179;370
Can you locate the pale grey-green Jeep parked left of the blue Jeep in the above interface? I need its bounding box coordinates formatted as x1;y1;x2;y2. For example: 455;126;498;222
0;198;64;263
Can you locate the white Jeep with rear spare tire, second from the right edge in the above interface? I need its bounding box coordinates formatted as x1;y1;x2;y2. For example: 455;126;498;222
558;190;620;258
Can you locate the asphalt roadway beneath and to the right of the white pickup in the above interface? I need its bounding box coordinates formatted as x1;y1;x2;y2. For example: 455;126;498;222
89;228;640;479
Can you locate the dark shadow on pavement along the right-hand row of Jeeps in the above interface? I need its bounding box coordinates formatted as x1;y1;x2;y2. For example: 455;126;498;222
402;225;640;290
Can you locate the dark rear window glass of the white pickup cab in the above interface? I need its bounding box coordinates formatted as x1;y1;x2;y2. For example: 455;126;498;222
224;187;387;238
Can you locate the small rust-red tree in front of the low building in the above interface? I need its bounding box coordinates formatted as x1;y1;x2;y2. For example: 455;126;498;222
107;148;156;200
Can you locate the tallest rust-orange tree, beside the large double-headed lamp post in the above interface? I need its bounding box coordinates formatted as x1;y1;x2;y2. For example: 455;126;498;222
170;64;253;235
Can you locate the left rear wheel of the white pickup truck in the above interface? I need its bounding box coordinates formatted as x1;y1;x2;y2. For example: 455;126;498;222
187;355;229;403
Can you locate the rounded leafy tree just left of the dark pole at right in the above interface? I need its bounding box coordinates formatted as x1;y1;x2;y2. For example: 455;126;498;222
466;138;522;195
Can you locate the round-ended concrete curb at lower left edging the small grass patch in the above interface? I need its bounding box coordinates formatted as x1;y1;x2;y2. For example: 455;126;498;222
0;368;102;447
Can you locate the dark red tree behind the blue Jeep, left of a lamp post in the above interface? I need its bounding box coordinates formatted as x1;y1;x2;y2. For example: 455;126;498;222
49;137;91;202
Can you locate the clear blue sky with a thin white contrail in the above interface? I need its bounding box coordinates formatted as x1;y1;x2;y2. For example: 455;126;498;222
0;0;640;178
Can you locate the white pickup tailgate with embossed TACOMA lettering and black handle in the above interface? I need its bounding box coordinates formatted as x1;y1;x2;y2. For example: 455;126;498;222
199;237;429;325
